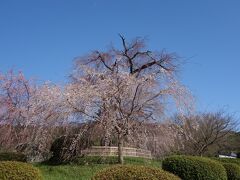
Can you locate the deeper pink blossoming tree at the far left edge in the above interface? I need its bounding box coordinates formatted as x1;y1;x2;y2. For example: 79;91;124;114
0;70;36;148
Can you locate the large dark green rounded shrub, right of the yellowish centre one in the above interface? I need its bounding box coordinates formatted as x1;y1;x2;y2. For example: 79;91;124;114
162;156;227;180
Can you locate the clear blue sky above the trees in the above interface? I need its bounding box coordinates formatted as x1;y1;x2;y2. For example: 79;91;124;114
0;0;240;115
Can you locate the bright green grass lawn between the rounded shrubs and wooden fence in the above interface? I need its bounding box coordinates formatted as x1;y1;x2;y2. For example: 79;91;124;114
35;158;161;180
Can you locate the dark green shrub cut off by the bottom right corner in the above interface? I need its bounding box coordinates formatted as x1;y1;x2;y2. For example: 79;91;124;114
222;163;240;180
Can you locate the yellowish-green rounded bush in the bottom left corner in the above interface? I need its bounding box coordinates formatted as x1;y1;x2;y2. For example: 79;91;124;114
0;161;42;180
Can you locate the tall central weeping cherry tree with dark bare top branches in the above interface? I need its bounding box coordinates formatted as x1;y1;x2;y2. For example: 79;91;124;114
65;35;190;163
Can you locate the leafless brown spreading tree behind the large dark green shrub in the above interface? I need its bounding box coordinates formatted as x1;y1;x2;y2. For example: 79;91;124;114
175;111;237;156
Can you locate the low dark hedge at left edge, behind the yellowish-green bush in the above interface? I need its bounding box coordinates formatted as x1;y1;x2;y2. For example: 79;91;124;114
0;152;27;162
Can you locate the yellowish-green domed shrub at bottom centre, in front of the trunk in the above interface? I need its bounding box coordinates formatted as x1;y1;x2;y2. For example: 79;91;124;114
92;165;180;180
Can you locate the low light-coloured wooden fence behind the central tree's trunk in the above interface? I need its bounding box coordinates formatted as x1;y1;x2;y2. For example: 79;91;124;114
82;146;152;159
